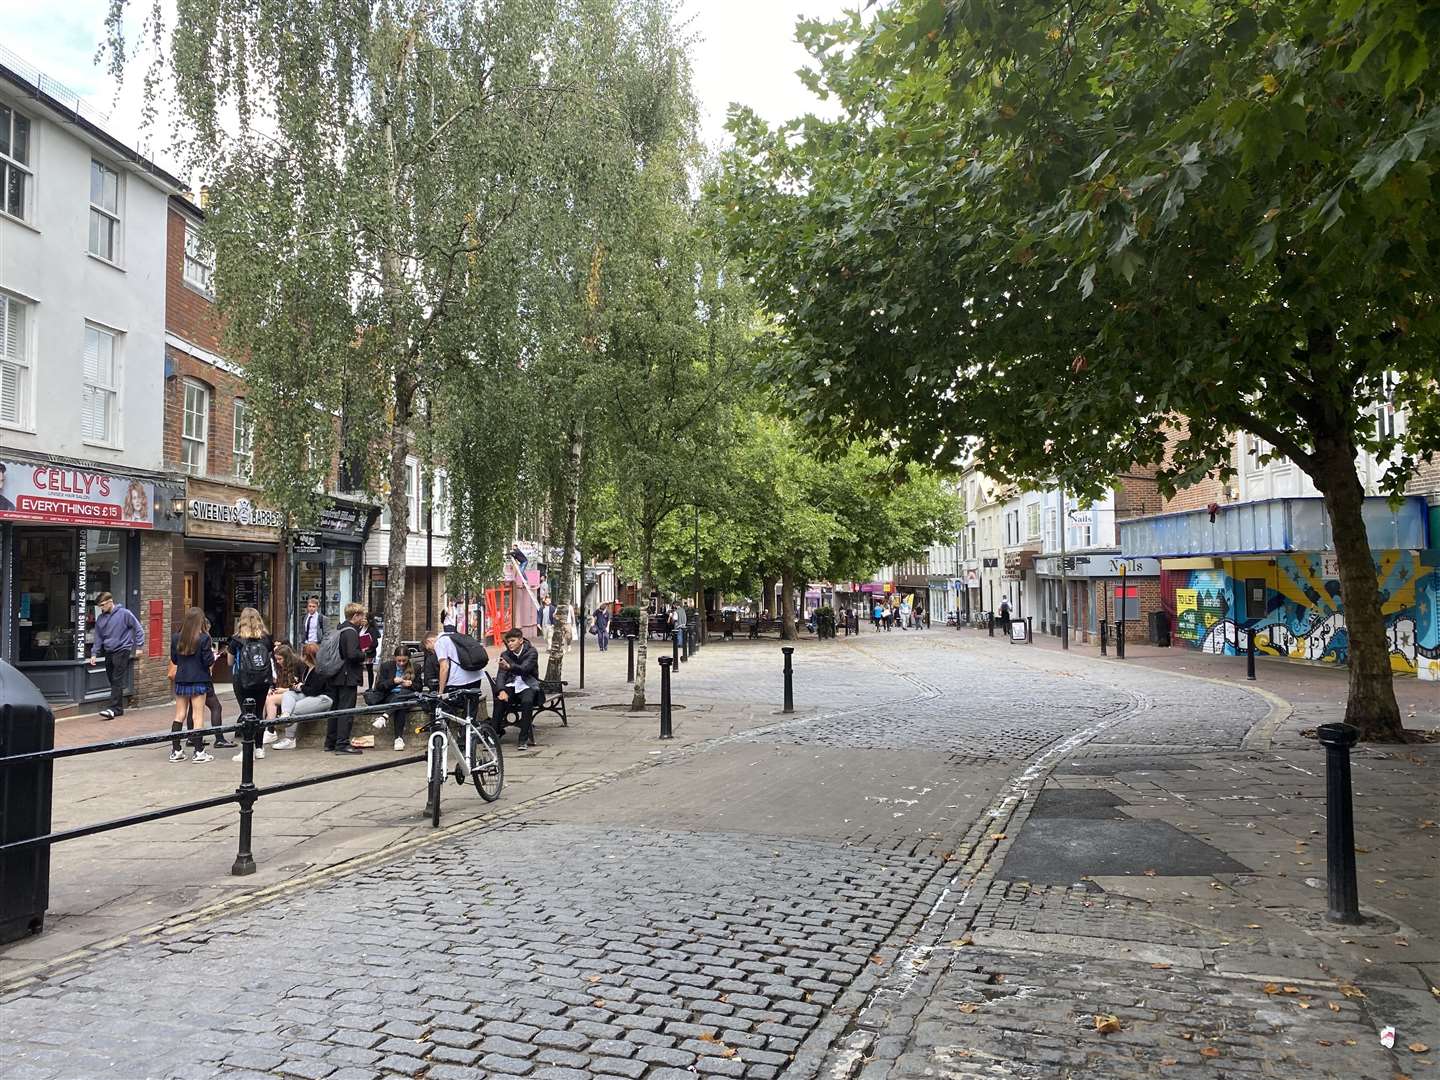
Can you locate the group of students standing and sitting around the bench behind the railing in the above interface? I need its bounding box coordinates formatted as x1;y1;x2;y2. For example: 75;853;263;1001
170;600;541;762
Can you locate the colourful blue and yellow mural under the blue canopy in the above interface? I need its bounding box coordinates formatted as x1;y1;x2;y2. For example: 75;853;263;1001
1166;550;1440;681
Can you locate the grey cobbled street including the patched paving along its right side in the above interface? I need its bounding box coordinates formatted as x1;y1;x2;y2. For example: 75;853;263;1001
0;631;1440;1080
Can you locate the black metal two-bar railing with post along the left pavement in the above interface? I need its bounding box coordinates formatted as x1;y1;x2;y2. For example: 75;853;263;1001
0;690;484;876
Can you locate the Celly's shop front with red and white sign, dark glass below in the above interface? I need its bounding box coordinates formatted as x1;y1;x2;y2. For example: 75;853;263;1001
0;459;180;704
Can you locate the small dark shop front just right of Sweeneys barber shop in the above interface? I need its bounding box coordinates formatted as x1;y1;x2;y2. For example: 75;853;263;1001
287;500;371;641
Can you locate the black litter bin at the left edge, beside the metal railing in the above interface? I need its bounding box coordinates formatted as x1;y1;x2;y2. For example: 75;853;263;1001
0;660;55;945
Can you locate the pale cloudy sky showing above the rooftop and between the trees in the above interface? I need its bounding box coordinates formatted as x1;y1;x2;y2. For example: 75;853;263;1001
0;0;857;167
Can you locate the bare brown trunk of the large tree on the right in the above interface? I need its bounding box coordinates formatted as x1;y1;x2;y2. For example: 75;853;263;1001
1310;435;1404;742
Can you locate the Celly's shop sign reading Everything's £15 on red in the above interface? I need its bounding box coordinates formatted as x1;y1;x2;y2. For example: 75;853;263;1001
0;461;156;528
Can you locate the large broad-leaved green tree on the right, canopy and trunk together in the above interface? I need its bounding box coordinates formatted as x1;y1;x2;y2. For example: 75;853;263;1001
723;0;1440;733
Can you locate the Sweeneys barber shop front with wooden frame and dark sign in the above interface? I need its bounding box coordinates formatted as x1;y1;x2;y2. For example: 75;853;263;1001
174;480;285;659
